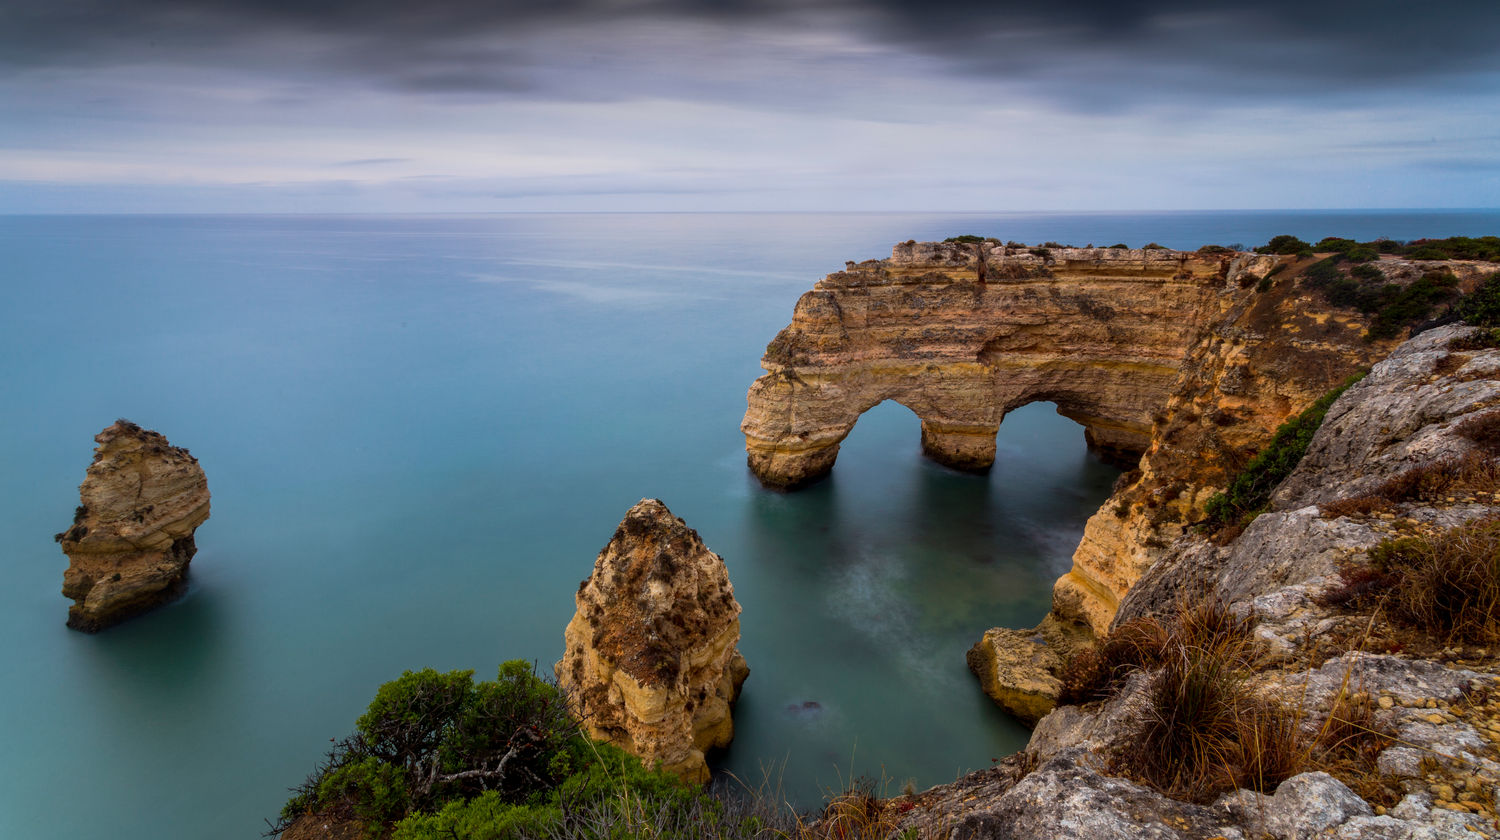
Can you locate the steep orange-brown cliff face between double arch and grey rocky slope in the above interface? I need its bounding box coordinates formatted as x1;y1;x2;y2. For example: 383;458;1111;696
1053;260;1494;633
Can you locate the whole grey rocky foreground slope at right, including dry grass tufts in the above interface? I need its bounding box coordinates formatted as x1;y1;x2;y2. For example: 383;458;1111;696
888;327;1500;840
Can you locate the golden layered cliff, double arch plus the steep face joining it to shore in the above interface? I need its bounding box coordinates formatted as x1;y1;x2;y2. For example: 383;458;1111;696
741;240;1493;636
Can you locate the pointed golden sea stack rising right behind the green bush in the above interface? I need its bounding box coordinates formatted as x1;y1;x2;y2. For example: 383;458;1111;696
557;500;750;783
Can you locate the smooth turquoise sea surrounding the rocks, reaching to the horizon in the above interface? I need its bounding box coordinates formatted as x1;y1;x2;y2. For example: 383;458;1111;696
0;212;1500;840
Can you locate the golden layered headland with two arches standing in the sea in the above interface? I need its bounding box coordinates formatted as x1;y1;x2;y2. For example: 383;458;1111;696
741;240;1274;489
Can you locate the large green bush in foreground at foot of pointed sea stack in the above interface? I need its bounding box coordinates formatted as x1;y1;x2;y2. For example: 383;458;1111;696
269;660;803;840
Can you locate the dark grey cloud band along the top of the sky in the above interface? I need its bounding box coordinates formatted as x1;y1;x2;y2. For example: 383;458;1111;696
11;0;1500;108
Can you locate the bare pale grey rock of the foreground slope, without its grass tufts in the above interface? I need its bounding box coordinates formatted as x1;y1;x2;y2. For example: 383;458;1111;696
891;327;1500;840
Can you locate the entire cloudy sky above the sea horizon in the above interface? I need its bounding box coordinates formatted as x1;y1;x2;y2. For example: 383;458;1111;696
0;0;1500;213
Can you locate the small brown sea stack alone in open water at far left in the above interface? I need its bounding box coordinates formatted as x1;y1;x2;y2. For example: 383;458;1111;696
57;420;209;633
